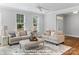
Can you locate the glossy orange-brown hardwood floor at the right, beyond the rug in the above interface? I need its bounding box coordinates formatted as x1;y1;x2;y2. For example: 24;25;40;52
63;36;79;55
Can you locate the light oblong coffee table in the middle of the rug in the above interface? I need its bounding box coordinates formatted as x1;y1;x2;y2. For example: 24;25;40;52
19;38;44;50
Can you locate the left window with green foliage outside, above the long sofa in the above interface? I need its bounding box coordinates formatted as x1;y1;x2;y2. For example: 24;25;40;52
17;14;24;30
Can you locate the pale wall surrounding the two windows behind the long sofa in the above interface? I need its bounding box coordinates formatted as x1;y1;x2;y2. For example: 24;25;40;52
0;8;44;33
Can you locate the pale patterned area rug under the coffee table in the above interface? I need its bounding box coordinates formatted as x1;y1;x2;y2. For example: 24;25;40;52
0;42;72;55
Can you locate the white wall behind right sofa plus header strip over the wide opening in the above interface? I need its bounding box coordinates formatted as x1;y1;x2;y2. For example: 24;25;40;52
38;6;79;31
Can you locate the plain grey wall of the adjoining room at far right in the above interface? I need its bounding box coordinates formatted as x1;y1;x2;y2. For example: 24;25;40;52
64;14;79;37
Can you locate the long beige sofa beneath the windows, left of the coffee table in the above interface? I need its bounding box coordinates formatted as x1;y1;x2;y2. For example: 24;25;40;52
8;31;29;45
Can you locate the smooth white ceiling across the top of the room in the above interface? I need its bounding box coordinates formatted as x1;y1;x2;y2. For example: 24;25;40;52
0;3;79;12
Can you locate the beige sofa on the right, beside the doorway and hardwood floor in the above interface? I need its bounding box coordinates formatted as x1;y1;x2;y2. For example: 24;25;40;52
43;31;64;45
